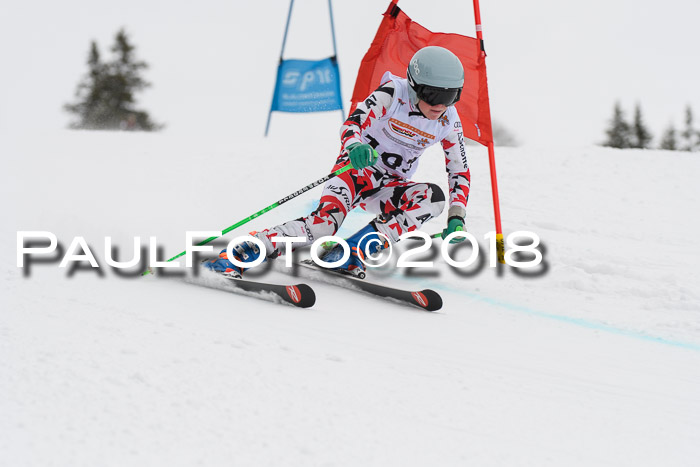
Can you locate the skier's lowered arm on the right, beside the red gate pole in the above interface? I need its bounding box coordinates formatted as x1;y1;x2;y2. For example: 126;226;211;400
441;121;471;238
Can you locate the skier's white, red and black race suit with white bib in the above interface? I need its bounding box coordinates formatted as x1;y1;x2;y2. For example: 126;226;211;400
258;72;470;257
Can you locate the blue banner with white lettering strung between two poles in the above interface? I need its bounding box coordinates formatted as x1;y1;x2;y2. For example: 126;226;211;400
270;57;343;112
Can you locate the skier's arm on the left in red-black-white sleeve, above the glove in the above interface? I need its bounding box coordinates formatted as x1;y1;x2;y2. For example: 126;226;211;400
340;81;394;154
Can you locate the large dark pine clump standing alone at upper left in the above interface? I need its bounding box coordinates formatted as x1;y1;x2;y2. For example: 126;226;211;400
64;29;160;131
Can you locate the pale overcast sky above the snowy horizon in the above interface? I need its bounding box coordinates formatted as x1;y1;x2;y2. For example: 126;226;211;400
0;0;700;146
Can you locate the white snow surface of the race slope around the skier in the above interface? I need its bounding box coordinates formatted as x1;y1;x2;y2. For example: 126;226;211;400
0;129;700;467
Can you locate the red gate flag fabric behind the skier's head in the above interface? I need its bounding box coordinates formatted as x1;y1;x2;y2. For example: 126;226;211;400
350;2;493;145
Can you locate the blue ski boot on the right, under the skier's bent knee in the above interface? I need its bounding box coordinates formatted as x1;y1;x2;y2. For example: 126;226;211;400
321;221;389;279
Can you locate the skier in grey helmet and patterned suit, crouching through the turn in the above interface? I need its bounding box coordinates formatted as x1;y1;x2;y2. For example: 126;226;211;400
204;46;470;278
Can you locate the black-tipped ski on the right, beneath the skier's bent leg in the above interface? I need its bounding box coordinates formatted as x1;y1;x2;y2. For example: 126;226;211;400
297;259;442;311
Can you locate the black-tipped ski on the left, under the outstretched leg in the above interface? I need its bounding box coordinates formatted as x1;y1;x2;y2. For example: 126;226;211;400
193;275;316;308
